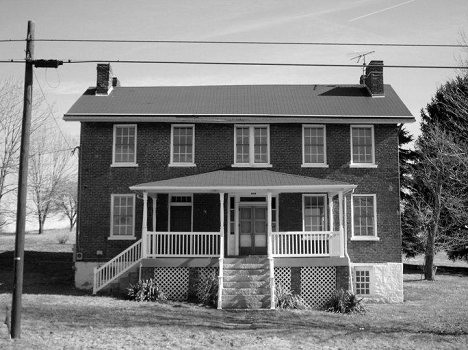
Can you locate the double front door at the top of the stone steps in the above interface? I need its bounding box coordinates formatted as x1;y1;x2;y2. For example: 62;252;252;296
239;206;267;255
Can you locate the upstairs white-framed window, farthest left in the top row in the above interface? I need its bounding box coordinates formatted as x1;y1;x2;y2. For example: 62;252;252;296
112;125;137;166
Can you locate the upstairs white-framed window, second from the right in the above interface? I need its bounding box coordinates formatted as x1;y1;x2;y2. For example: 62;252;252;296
302;125;328;167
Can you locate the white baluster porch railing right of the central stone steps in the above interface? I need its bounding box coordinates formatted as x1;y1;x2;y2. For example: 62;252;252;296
271;231;339;257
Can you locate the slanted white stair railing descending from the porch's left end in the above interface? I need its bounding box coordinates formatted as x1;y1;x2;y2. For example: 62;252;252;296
93;239;142;294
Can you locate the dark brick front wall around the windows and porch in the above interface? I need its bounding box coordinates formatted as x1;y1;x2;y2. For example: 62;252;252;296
77;123;401;263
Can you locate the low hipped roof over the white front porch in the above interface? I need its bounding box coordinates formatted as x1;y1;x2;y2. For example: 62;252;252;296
130;169;356;193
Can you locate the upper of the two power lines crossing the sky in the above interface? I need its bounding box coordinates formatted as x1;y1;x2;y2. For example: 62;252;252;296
0;39;468;48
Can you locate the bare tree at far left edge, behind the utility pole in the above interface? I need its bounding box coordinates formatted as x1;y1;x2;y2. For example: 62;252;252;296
0;79;46;230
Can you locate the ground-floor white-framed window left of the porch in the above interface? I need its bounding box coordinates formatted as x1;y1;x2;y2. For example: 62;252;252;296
110;194;135;239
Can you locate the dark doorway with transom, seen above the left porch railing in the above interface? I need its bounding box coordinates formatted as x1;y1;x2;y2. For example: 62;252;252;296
169;195;192;232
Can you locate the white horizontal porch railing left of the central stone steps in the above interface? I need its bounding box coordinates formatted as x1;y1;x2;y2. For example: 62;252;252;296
145;232;221;258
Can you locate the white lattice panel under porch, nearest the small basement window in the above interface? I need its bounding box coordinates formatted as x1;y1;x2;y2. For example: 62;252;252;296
301;266;336;307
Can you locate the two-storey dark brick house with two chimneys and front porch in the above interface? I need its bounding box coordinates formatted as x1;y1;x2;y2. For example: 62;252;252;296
64;61;414;308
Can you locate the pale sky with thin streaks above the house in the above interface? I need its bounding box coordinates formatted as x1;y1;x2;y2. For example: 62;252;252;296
0;0;468;141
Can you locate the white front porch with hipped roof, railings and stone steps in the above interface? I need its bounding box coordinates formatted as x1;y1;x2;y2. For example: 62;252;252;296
95;170;355;309
